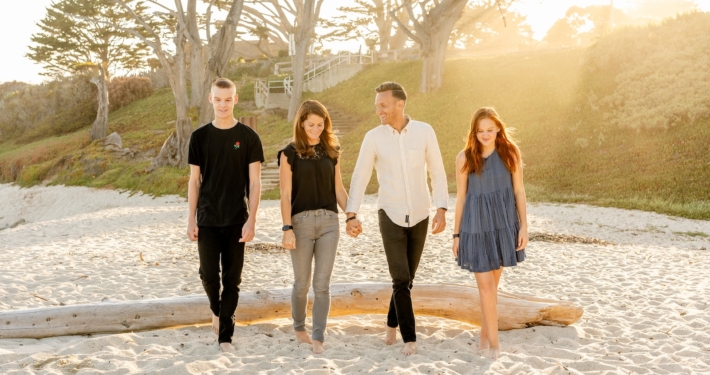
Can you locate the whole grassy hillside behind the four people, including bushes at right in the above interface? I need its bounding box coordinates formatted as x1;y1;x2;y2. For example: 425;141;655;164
0;13;710;220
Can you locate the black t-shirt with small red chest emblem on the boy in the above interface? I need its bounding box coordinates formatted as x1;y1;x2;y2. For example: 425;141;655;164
187;122;264;227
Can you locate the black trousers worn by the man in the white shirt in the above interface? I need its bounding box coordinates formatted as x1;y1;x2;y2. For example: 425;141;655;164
378;210;429;342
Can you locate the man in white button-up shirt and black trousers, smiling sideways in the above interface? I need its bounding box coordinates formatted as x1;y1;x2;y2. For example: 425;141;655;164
346;82;448;356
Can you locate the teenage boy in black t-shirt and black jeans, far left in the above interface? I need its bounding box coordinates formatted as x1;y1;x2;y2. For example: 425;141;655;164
187;78;264;353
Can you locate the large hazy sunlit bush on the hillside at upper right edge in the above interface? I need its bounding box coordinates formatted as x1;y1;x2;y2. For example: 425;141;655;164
587;13;710;129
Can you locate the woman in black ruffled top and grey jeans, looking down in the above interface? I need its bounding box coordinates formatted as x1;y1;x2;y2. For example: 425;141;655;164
278;100;348;354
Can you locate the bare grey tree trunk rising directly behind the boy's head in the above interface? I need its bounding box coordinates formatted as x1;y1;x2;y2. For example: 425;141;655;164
197;0;244;125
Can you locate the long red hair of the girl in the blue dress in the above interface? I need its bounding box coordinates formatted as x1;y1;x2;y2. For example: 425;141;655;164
463;107;523;176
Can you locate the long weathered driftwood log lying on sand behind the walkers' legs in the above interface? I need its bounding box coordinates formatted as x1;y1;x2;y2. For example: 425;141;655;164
0;283;582;338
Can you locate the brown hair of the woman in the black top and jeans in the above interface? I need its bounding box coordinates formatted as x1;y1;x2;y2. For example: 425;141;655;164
293;100;340;159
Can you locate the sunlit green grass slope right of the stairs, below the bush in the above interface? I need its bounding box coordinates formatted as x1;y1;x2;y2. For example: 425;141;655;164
309;49;710;220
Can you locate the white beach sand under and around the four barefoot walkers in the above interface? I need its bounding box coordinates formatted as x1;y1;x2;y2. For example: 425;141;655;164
0;185;710;374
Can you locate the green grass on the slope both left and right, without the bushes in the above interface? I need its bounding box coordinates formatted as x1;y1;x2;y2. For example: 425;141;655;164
0;14;710;220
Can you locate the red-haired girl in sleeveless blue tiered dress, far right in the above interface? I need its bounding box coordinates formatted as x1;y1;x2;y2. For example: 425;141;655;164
452;107;528;359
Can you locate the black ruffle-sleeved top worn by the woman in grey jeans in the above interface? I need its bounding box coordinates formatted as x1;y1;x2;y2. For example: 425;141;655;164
277;143;338;216
